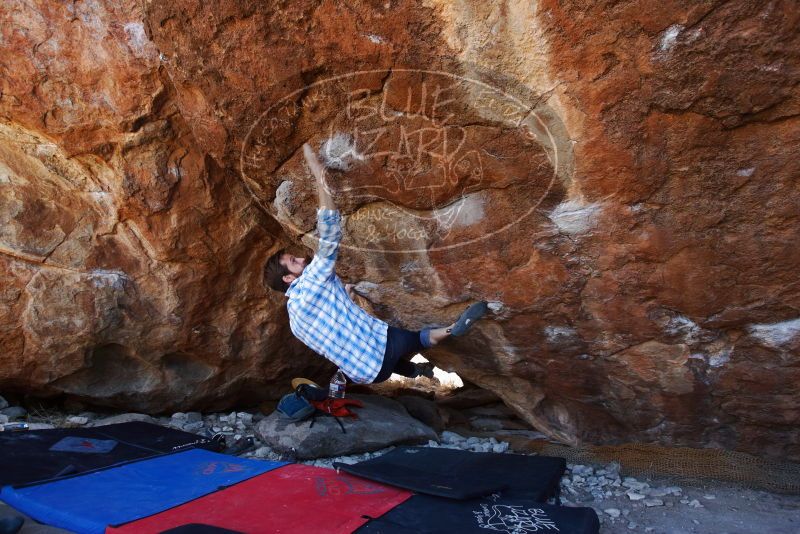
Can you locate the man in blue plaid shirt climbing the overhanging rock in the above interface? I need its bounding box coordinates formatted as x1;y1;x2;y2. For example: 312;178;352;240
264;144;487;384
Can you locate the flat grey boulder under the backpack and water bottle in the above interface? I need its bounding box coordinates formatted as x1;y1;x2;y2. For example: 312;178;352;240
256;395;437;460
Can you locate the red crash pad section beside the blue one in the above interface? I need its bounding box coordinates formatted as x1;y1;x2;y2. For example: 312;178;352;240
108;464;411;534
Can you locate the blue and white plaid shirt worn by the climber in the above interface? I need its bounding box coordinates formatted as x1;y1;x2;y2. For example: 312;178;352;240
286;208;389;384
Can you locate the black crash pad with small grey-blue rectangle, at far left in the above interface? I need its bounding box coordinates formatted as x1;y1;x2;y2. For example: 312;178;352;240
0;422;216;486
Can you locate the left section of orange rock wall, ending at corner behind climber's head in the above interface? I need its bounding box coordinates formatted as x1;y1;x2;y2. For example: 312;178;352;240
0;2;332;411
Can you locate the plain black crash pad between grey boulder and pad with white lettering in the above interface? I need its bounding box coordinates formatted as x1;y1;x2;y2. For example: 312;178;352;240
334;447;567;502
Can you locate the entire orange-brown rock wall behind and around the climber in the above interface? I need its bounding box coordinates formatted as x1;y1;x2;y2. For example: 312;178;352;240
0;0;800;459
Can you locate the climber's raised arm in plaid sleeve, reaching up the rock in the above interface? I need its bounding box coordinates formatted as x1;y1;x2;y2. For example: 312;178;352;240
303;143;342;282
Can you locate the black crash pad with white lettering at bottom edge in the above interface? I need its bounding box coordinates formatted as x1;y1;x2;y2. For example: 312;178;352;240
356;495;600;534
